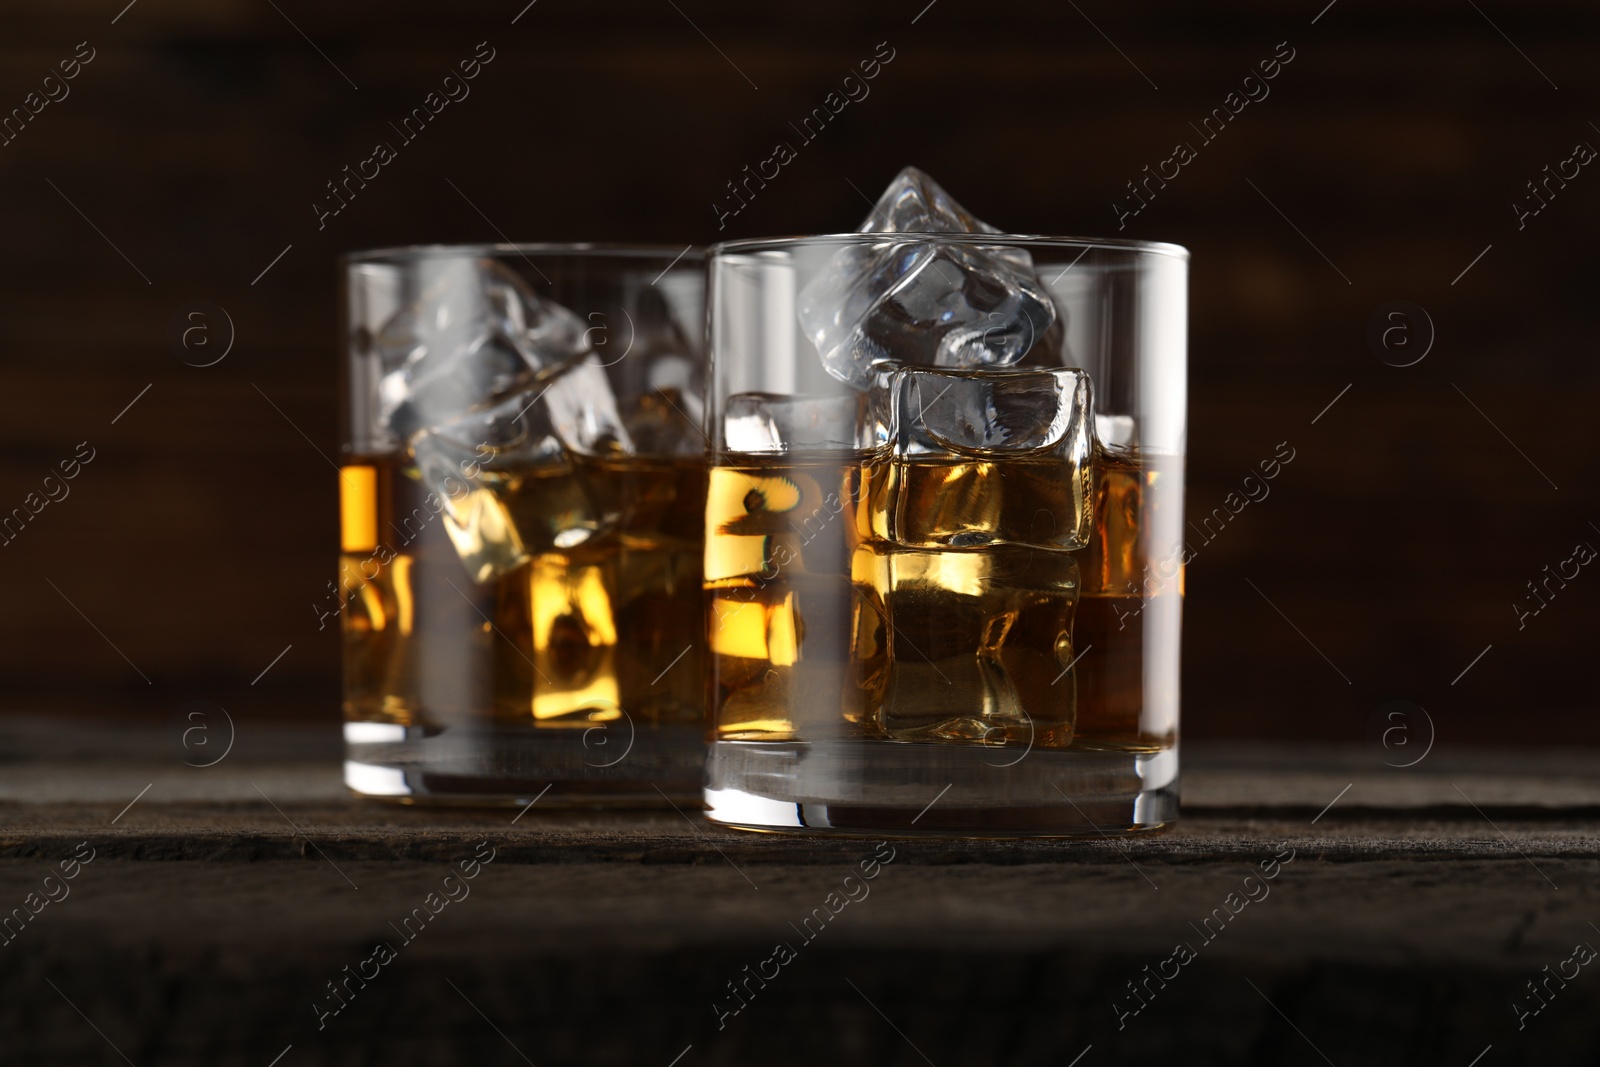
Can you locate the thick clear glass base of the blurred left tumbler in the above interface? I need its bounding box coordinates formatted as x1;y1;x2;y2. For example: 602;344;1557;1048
344;721;706;808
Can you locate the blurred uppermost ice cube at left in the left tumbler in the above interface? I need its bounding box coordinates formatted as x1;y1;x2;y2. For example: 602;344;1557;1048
373;256;586;440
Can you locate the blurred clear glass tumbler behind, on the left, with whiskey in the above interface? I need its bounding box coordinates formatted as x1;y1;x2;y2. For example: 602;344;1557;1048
334;245;706;805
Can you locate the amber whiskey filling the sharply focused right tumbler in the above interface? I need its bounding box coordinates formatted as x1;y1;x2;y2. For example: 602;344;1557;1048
706;451;1181;752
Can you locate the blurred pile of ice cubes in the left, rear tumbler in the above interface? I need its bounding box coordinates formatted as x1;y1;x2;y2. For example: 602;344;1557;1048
374;256;704;582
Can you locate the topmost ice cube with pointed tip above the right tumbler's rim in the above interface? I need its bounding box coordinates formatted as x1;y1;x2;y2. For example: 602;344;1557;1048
797;166;1056;389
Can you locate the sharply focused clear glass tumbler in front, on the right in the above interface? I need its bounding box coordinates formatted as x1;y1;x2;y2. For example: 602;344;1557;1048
706;234;1189;835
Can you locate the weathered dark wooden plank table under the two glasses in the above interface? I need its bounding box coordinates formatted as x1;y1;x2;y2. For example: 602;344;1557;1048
0;718;1600;1067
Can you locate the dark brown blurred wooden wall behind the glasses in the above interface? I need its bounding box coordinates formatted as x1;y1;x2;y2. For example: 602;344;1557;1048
0;0;1600;742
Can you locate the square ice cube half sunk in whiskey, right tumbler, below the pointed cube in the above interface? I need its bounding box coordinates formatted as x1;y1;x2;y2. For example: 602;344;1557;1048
872;368;1093;552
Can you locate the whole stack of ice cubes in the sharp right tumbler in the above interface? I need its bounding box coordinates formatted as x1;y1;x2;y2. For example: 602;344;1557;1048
723;168;1093;744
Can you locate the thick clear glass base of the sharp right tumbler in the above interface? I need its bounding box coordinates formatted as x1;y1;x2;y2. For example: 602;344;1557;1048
706;741;1178;837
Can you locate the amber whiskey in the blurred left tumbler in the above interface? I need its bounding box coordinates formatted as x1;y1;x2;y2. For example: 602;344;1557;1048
339;456;706;748
